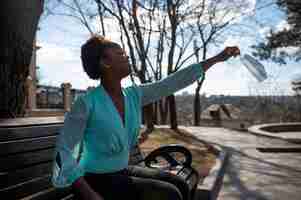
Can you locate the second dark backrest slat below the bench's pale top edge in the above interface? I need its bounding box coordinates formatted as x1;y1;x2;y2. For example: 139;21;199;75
0;136;56;156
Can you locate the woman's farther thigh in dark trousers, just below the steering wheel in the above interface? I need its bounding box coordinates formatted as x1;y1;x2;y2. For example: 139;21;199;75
128;166;190;200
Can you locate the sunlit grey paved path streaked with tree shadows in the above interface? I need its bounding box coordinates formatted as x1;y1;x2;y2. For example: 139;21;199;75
181;127;301;200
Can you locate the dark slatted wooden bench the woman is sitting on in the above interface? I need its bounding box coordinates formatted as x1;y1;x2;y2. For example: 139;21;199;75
0;117;199;200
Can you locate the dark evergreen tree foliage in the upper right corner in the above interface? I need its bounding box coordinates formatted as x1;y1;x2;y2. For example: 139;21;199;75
252;0;301;64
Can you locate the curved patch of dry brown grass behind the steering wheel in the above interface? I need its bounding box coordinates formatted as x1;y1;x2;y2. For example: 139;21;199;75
139;128;216;177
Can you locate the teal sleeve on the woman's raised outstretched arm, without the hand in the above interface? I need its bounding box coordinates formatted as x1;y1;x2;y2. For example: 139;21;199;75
139;64;205;106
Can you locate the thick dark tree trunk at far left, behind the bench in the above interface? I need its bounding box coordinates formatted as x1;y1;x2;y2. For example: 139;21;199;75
0;0;43;118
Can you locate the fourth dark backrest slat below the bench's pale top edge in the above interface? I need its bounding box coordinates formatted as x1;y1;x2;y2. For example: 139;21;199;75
0;161;53;189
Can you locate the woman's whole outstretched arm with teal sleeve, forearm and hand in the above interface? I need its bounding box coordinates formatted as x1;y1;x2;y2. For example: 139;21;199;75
139;47;240;106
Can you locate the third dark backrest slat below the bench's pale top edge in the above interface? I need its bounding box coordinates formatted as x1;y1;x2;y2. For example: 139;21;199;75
0;148;54;172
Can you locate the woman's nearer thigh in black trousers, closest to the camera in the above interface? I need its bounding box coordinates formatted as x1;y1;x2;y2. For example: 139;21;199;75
74;171;183;200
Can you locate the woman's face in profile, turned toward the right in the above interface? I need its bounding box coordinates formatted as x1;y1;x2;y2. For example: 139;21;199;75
104;47;131;79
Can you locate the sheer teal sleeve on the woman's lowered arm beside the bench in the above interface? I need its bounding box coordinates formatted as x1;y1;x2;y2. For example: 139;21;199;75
52;97;89;187
